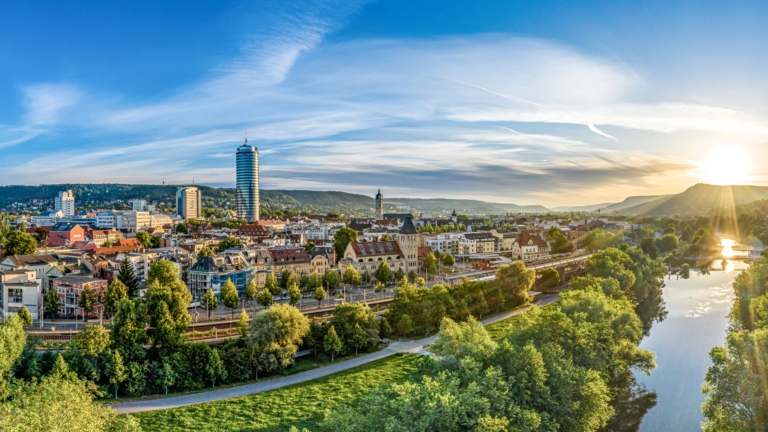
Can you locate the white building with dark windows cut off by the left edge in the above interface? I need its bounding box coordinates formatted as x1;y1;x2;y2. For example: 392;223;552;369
0;270;43;319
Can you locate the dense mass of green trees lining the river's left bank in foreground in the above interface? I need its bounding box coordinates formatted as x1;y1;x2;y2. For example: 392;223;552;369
322;251;655;432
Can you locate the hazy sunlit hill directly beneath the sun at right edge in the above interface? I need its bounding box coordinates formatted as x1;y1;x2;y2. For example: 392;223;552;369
620;184;768;216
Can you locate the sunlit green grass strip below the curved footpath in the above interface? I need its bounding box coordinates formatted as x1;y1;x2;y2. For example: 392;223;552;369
140;354;426;432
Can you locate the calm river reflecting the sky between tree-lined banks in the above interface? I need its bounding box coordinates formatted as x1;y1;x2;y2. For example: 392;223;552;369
636;253;748;432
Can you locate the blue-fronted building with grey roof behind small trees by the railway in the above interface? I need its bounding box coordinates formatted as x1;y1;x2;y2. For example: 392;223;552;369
187;249;254;301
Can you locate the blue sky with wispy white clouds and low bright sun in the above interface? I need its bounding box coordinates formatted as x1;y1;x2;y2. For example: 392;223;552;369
0;0;768;206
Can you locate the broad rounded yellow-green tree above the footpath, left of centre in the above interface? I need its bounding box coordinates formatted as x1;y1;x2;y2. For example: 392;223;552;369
251;304;309;371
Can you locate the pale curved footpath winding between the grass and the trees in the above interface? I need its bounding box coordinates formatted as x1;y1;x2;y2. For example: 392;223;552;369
107;294;559;414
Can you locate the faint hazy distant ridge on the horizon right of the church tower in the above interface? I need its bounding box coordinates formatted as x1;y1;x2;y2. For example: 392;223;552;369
384;197;549;214
